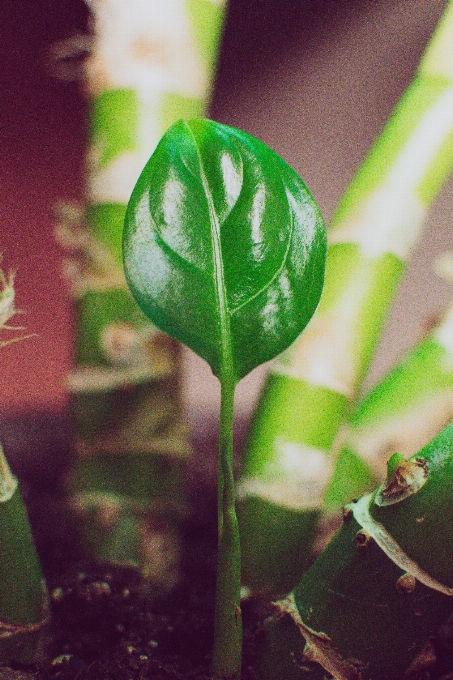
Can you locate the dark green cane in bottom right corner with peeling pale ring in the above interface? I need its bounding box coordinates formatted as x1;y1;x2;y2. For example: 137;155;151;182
264;424;453;680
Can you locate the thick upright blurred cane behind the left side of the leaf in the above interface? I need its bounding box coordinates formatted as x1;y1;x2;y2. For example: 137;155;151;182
60;0;225;587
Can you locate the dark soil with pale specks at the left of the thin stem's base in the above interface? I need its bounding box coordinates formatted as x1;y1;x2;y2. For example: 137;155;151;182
32;524;268;680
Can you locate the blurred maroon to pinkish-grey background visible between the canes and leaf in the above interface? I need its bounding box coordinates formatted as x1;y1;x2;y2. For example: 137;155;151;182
0;0;453;428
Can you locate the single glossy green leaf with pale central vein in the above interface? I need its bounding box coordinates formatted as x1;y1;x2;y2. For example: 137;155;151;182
124;119;326;381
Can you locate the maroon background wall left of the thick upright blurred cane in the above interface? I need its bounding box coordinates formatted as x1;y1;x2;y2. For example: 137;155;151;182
0;0;87;411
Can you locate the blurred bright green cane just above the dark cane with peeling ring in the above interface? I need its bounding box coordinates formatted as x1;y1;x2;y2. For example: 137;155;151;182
324;258;453;514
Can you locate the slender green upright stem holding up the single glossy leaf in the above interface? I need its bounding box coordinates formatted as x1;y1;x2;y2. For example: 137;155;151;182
213;379;242;678
